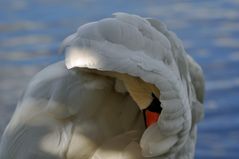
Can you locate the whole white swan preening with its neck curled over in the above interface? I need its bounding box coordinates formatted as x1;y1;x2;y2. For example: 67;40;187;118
0;13;204;159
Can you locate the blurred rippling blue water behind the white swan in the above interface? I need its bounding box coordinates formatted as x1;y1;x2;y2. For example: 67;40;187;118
0;0;239;159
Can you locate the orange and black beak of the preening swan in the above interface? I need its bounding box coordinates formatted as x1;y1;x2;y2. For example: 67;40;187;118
143;93;162;127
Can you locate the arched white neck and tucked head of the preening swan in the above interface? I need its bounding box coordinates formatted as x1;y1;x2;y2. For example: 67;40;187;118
62;13;204;158
